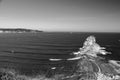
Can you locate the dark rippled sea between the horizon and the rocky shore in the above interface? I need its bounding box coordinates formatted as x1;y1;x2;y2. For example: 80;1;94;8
0;32;120;77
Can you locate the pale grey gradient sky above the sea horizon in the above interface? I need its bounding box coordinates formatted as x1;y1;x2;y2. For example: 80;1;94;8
0;0;120;32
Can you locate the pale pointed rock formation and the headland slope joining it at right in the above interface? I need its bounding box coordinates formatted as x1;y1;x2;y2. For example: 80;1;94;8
68;36;120;80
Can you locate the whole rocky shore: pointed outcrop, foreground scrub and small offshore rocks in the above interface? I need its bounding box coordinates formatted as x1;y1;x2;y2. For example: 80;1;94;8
0;36;120;80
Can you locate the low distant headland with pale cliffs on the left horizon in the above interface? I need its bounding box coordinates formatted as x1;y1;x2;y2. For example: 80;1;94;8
0;28;43;33
